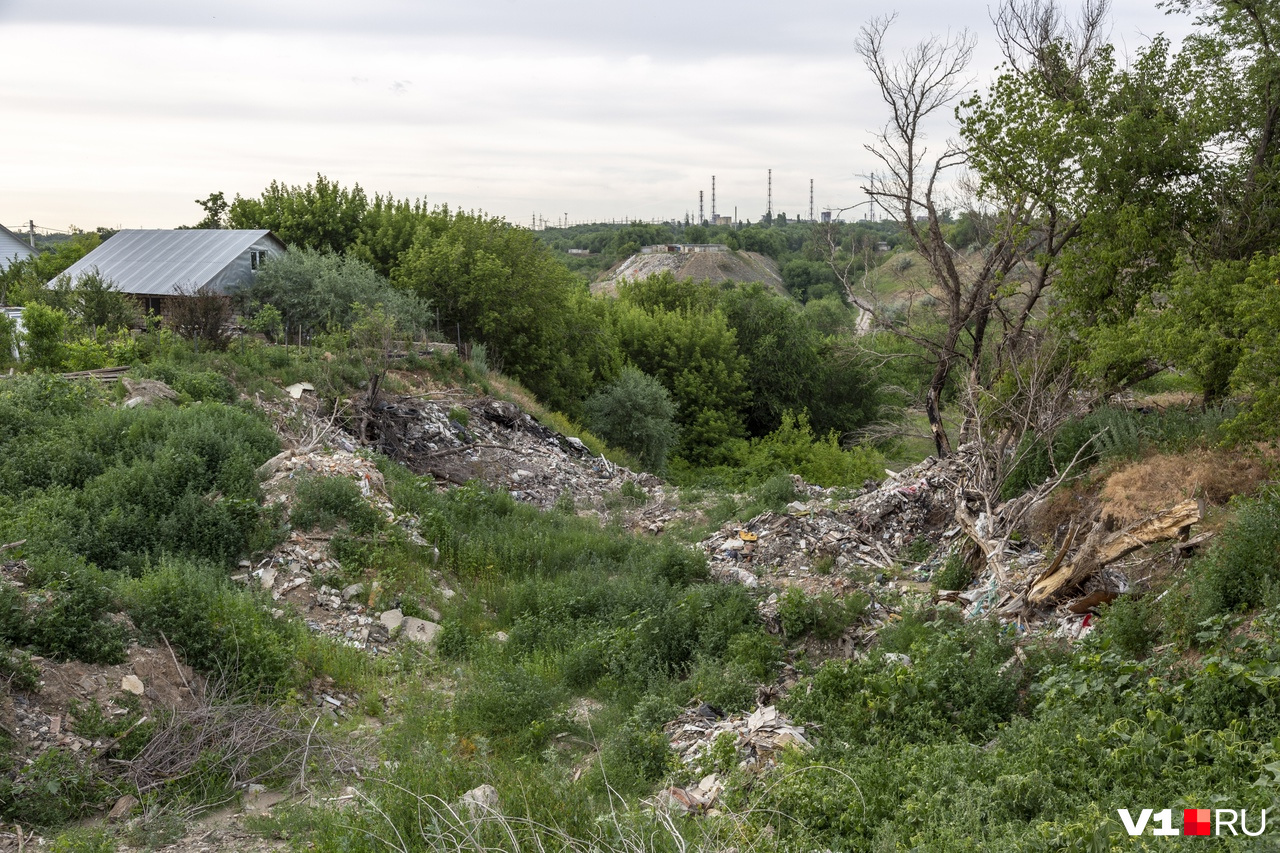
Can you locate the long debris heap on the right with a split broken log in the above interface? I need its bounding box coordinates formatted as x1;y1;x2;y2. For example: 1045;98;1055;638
700;447;1204;637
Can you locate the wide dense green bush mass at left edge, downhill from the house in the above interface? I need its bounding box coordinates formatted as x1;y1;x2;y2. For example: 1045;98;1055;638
0;377;279;570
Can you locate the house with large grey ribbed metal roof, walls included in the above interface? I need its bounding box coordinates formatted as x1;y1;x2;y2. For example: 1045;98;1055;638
56;228;284;313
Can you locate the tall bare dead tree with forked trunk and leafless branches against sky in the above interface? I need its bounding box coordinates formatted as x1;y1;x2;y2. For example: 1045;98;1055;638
826;0;1108;456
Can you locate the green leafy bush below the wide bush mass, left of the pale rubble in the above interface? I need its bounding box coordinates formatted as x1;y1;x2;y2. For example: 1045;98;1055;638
122;560;303;694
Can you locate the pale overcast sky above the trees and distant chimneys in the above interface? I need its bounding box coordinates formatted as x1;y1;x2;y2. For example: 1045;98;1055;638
0;0;1187;228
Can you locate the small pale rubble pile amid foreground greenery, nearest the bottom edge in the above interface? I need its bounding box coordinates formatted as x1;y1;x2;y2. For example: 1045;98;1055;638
664;703;812;815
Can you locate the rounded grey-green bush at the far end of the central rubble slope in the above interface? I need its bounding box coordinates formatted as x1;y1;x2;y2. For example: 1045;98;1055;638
586;368;678;471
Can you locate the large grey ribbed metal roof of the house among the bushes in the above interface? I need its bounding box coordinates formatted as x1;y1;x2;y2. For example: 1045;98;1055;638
58;228;283;296
